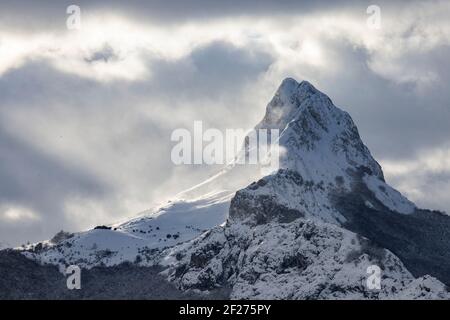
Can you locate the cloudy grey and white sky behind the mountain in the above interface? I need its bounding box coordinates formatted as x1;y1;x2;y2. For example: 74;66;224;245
0;0;450;245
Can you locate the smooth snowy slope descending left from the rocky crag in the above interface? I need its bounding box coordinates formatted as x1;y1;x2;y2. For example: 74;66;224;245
24;192;233;268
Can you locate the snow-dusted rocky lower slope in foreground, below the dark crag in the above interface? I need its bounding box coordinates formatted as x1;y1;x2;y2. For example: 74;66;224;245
163;219;450;299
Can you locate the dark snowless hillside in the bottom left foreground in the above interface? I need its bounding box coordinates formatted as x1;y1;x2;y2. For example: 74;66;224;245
0;250;227;300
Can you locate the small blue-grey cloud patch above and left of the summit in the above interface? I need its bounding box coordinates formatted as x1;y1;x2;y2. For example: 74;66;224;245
137;42;273;99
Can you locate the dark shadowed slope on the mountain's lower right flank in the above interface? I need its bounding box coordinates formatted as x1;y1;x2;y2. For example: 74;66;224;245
332;169;450;285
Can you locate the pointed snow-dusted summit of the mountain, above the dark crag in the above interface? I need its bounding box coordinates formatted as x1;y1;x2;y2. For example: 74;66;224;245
256;78;384;188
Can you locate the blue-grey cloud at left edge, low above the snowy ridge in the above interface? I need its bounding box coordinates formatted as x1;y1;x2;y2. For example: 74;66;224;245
0;126;105;214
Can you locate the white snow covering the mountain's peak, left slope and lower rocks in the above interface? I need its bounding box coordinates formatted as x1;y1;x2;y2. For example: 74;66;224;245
17;79;436;299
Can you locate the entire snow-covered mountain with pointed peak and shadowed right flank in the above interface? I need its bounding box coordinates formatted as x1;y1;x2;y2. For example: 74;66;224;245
18;78;450;299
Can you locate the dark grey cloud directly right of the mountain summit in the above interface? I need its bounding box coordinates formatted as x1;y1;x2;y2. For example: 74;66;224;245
300;41;450;159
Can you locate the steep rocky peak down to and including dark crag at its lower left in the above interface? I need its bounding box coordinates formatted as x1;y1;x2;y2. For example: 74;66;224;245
229;78;415;225
